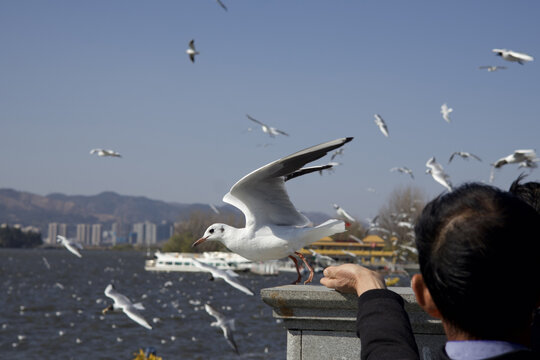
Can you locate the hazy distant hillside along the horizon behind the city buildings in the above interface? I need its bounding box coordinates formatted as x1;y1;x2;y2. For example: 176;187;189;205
0;189;329;232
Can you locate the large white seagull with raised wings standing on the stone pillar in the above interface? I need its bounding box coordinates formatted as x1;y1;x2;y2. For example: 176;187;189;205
193;137;353;284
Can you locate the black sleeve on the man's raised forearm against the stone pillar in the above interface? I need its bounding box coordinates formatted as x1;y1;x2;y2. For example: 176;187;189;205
356;289;420;360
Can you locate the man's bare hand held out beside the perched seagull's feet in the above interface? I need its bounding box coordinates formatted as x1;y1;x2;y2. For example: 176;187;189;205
321;264;386;296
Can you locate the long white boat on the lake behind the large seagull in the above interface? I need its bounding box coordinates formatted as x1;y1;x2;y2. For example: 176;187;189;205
144;251;252;272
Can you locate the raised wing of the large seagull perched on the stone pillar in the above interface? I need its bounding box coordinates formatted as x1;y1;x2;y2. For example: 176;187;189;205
223;137;353;226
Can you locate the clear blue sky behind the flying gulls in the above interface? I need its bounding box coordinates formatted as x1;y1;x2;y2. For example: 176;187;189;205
0;0;540;219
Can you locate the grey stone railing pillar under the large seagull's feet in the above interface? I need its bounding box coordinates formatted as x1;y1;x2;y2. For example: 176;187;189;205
261;285;446;360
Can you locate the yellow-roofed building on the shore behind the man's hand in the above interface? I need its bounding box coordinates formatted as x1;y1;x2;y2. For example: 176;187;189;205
300;235;397;265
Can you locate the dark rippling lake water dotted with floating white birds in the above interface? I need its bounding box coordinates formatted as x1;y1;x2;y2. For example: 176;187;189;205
0;249;296;360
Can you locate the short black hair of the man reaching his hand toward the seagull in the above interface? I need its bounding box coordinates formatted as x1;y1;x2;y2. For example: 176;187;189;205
415;183;540;339
